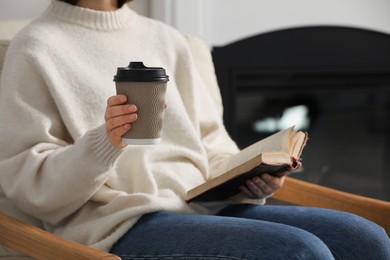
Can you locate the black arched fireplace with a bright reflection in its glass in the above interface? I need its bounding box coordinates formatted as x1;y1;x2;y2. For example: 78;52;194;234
213;26;390;201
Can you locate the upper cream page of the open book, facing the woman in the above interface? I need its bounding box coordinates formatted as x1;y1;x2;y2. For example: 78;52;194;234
224;127;294;174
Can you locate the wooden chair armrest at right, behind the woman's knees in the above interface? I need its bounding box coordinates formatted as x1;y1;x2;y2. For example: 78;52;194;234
273;178;390;235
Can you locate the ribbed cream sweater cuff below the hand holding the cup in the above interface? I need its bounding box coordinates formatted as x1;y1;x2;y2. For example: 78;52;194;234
87;125;123;166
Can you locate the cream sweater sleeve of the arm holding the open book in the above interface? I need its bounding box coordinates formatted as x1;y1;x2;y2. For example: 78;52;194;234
177;35;239;178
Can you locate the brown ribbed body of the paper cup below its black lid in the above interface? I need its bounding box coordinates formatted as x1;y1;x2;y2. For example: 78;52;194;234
116;82;167;139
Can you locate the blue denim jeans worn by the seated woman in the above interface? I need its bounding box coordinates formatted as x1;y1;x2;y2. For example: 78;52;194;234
111;205;390;260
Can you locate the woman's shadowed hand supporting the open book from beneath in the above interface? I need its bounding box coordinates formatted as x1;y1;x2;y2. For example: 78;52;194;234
239;162;302;199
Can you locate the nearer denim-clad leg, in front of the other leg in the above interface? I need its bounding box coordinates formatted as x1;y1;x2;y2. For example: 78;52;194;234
111;209;333;260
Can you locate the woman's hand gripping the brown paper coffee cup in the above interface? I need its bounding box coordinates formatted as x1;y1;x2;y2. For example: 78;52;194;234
104;95;138;148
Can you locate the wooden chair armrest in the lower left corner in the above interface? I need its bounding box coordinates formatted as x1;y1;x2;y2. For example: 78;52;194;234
0;213;120;260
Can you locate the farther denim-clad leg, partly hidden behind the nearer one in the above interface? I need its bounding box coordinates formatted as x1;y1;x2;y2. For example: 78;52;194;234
220;205;390;260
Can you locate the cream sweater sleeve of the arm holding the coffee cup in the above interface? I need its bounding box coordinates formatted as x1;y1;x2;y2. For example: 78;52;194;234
0;50;122;224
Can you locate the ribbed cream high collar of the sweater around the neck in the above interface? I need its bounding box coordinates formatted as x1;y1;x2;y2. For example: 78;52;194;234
46;0;135;31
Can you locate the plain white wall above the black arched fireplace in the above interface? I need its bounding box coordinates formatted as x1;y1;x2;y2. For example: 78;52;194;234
165;0;390;46
